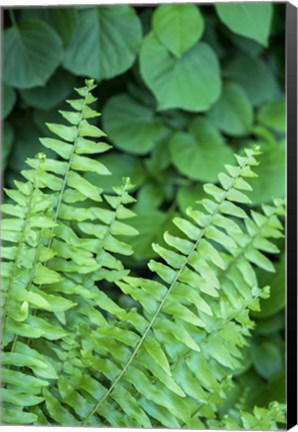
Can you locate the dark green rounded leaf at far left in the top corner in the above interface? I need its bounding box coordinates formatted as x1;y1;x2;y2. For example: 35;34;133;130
3;20;63;89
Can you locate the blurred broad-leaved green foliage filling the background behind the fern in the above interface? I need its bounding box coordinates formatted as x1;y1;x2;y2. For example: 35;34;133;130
2;3;285;422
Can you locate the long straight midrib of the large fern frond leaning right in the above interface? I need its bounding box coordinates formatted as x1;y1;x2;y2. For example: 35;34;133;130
81;157;254;424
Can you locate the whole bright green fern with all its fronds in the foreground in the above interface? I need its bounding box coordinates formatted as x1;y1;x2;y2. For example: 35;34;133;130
1;80;284;429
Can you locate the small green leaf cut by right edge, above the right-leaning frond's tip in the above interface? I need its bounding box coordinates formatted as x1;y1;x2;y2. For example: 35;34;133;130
258;100;286;132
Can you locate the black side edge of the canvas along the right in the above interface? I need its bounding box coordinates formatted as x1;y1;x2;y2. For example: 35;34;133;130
286;2;297;429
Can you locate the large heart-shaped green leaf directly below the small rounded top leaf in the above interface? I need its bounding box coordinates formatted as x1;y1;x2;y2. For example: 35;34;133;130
140;33;221;112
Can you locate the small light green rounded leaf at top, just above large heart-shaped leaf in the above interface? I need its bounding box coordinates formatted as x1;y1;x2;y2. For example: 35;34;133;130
152;4;204;57
